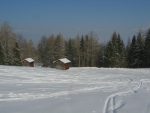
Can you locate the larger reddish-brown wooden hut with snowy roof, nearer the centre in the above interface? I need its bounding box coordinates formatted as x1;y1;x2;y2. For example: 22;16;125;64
53;58;71;70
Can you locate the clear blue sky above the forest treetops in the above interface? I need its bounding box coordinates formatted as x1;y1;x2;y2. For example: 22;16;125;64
0;0;150;41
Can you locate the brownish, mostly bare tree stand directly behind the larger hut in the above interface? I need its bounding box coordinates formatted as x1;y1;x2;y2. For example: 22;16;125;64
38;33;100;67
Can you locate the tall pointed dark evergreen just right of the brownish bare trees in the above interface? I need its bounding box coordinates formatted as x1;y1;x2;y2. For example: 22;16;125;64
105;32;126;67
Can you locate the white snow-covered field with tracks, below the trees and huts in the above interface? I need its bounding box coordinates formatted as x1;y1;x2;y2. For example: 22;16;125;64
0;66;150;113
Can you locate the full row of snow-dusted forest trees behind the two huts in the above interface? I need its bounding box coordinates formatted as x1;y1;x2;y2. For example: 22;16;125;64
0;23;150;68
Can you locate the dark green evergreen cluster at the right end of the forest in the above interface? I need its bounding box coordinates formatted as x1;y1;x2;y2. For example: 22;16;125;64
100;29;150;68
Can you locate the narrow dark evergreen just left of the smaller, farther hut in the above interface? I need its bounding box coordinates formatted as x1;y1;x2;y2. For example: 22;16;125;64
13;42;22;66
